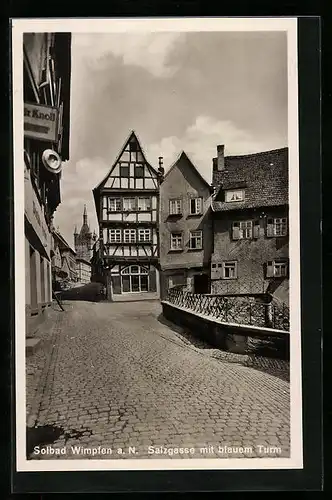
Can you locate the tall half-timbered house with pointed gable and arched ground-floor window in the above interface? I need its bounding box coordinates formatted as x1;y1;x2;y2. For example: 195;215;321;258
93;132;159;301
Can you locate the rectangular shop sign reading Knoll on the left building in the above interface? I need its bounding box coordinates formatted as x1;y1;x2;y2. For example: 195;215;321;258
24;103;59;142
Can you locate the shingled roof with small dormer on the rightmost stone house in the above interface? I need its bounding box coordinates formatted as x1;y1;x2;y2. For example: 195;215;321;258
212;148;288;212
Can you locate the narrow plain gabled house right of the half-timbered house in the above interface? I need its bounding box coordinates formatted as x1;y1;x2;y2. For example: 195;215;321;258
159;152;212;298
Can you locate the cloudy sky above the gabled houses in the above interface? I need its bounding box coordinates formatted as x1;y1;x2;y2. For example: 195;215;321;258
54;32;288;246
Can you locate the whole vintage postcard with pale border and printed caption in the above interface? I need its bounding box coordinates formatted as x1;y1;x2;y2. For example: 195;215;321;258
12;18;303;471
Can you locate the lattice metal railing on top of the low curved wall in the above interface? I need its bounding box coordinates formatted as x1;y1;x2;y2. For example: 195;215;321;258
166;287;289;331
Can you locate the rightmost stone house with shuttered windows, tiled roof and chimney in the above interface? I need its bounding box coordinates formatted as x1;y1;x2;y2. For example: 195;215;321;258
211;146;289;303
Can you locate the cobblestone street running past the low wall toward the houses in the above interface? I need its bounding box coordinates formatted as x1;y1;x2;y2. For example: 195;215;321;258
27;301;290;459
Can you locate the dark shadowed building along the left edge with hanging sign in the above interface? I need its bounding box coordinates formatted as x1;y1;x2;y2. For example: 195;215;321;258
23;33;71;336
